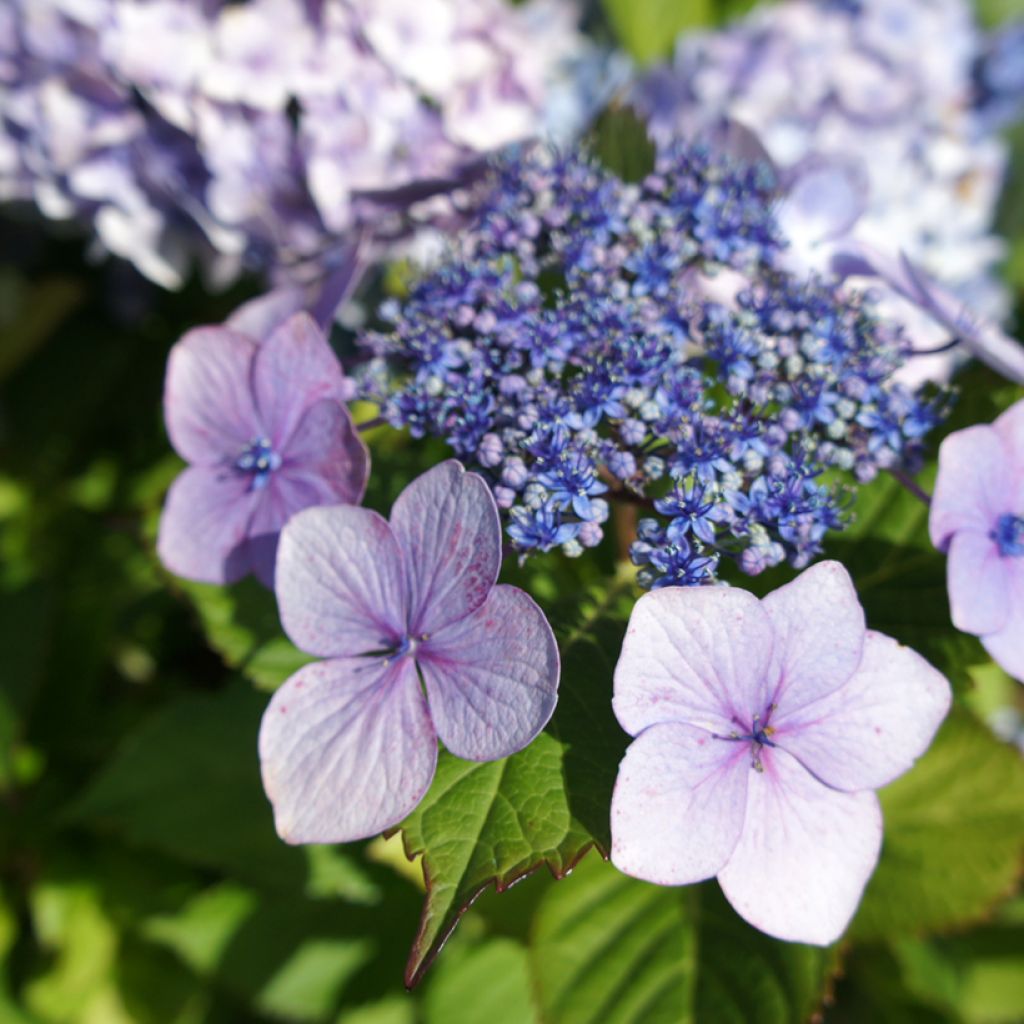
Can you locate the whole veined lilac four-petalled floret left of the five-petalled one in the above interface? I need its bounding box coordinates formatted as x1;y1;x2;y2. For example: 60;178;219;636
259;461;559;843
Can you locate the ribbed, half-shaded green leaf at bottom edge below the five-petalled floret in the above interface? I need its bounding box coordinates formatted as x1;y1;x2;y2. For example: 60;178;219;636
530;856;837;1024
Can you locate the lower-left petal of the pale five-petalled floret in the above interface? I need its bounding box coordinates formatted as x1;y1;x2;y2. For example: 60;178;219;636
611;722;751;886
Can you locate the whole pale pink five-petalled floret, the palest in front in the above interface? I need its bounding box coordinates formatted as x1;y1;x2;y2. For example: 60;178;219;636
611;561;950;945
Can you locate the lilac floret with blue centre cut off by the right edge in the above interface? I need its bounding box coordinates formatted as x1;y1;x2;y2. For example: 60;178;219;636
929;399;1024;682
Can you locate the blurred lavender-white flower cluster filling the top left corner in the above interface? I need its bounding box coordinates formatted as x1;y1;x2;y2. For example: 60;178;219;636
0;0;583;288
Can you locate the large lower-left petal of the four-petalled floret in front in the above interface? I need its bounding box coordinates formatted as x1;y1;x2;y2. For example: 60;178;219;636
259;657;437;843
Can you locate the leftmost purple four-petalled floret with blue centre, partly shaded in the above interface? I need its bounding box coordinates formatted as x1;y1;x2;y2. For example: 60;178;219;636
157;306;370;587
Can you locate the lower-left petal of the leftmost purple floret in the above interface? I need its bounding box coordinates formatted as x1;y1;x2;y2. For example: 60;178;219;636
157;466;259;584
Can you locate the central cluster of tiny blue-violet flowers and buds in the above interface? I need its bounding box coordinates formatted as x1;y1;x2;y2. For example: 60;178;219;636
361;145;941;587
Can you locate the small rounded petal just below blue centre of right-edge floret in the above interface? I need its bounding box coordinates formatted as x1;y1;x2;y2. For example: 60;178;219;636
946;529;1010;636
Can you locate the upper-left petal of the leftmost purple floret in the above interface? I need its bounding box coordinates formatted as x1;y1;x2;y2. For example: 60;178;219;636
164;327;262;466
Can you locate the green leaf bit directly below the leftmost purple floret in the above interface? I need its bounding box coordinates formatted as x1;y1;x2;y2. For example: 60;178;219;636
181;577;312;690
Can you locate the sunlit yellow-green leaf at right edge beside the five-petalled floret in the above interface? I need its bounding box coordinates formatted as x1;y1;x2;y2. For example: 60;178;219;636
850;711;1024;939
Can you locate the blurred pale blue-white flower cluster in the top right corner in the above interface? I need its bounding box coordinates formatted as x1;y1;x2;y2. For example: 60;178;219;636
631;0;1020;382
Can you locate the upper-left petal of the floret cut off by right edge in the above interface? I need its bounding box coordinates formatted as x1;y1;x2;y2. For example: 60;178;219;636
928;424;1013;551
